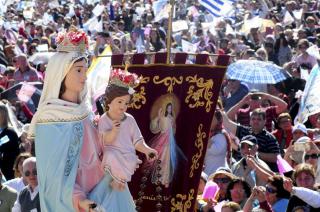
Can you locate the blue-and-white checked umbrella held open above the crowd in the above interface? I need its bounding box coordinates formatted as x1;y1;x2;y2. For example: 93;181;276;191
227;60;290;84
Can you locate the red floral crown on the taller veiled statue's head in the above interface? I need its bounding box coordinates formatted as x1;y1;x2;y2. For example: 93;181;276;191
56;26;89;53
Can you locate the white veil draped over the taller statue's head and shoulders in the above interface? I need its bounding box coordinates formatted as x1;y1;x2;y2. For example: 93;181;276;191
28;52;91;137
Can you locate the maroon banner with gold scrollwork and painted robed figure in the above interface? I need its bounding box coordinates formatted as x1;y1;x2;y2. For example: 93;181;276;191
121;64;226;212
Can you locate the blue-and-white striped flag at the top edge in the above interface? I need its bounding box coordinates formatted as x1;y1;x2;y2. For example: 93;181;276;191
200;0;236;17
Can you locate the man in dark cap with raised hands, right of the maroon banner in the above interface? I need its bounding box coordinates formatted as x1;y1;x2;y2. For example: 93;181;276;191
232;135;272;188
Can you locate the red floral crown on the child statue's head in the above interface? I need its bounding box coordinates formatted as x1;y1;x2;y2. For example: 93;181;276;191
110;69;139;94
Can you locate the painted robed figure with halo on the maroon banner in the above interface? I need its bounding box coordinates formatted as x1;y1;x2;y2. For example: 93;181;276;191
144;94;185;188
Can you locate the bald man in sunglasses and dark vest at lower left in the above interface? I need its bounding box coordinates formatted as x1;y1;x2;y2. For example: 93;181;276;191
12;157;40;212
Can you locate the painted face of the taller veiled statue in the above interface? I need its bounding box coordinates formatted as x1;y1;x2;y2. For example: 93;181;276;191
65;59;88;95
